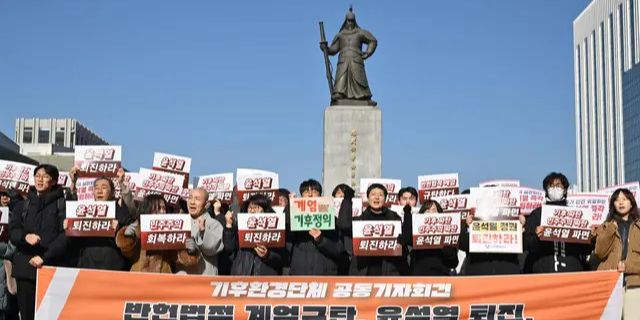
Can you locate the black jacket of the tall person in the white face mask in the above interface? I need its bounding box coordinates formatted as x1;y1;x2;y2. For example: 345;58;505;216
524;200;593;273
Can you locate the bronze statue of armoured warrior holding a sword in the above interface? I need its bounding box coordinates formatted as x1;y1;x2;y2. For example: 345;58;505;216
320;8;378;106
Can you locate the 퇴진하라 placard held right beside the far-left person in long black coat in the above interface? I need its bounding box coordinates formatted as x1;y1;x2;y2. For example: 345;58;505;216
65;201;116;237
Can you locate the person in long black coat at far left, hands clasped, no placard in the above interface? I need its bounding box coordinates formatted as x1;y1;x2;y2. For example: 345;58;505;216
9;164;67;320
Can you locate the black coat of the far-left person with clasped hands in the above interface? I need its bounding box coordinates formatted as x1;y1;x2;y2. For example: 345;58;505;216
9;185;67;280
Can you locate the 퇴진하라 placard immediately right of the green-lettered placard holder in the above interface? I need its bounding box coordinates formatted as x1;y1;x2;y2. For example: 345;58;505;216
352;220;402;256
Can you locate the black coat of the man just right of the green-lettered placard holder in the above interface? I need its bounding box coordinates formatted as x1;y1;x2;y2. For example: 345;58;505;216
345;208;409;276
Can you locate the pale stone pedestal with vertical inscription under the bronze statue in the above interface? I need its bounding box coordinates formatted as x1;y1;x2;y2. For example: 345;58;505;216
322;105;382;195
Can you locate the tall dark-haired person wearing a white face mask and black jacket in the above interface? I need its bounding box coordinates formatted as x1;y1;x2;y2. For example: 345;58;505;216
524;172;593;273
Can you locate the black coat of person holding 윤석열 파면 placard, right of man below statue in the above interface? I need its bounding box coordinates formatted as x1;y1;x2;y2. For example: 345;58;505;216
402;206;458;276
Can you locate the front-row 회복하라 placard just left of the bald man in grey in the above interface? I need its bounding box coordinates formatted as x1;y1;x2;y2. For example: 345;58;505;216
140;213;191;250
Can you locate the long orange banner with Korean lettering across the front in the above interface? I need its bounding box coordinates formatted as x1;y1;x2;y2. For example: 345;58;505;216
36;267;622;320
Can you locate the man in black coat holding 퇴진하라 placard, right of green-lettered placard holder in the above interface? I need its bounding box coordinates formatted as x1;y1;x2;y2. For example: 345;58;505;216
345;183;409;276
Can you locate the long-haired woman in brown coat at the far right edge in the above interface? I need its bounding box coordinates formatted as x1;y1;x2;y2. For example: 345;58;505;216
594;189;640;319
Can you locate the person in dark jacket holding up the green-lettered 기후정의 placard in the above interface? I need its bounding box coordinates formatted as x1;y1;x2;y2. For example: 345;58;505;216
287;179;343;276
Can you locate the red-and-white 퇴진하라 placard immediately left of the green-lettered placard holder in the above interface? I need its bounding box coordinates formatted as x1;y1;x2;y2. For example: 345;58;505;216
238;213;286;248
